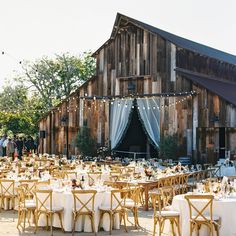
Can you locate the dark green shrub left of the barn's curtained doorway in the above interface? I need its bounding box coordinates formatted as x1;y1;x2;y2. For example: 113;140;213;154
76;126;97;156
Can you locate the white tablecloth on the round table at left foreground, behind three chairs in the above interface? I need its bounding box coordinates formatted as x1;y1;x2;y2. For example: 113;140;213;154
39;190;120;232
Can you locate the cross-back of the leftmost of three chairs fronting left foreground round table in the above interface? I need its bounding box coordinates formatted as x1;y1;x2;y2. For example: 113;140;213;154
34;189;52;212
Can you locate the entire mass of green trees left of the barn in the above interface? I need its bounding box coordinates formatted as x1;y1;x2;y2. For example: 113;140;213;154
0;52;96;135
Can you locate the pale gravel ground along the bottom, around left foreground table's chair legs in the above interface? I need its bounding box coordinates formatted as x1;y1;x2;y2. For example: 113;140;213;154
0;210;153;236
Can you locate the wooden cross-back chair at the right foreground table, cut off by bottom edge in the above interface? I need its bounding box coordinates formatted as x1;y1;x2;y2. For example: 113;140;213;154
185;195;220;236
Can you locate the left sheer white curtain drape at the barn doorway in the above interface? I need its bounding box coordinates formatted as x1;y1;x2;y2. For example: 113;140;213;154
110;99;133;149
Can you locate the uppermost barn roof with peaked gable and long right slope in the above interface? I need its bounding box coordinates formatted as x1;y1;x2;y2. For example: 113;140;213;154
95;13;236;65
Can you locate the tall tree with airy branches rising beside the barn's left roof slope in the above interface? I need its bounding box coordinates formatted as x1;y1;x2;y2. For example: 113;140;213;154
20;52;96;108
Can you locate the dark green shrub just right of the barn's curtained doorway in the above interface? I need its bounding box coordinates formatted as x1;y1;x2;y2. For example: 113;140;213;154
159;134;178;159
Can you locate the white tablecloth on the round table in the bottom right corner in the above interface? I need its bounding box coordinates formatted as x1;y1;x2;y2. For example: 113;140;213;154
172;195;236;236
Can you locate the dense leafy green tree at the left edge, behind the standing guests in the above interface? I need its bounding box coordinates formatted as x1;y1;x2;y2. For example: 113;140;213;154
0;84;43;135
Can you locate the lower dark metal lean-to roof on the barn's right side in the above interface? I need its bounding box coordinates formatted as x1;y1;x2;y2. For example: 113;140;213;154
176;68;236;106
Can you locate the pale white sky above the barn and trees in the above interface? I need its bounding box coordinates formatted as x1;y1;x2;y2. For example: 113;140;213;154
0;0;236;86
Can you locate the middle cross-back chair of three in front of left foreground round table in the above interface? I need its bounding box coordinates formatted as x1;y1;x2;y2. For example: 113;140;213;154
71;190;97;235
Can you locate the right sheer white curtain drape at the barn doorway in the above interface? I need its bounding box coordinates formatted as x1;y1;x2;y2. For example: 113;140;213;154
137;98;160;147
